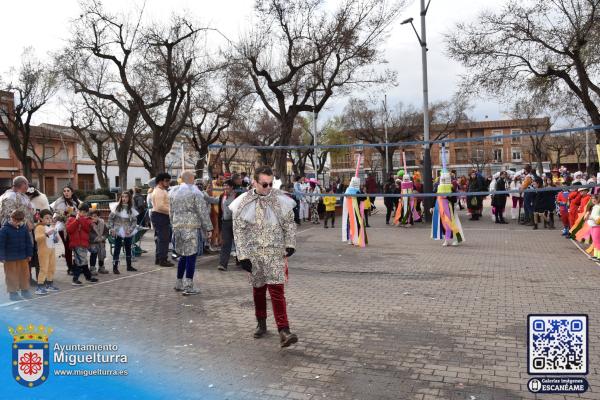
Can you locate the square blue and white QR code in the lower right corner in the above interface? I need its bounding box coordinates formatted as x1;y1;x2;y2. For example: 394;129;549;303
527;315;588;375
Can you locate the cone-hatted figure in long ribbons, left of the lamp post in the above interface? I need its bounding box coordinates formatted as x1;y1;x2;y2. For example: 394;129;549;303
342;157;368;247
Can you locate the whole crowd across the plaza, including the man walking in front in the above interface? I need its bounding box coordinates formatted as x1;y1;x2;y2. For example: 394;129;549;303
0;165;600;347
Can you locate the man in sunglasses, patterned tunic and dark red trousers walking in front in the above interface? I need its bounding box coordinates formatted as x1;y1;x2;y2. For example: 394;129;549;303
229;166;298;347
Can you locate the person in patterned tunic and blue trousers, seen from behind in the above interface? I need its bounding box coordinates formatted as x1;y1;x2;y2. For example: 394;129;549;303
169;171;213;296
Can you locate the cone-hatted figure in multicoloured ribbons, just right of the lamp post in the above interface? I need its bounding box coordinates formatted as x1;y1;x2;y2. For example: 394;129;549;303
431;148;465;246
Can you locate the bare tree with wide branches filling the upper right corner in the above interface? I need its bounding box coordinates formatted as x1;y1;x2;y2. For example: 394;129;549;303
447;0;600;143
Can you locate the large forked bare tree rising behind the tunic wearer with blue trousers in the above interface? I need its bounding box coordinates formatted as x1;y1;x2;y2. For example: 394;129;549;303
64;0;213;175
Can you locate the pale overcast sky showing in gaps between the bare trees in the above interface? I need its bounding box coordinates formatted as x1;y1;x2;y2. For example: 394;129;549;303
0;0;506;124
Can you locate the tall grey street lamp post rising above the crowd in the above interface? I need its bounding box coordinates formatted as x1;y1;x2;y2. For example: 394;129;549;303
402;0;433;221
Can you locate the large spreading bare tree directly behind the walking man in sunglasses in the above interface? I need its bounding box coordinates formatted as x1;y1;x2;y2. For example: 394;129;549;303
235;0;404;181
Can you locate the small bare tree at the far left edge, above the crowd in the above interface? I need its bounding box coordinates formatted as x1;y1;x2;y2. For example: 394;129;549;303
0;48;58;184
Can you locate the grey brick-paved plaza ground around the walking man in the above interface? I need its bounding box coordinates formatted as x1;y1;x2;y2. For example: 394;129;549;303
0;202;600;400
